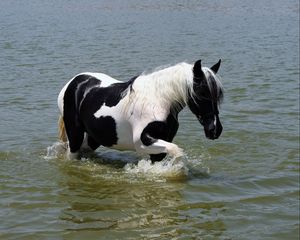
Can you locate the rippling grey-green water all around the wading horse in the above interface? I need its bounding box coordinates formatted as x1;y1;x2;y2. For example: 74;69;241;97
0;0;299;239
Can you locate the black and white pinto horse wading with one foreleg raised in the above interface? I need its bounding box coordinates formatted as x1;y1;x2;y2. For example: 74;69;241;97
57;59;223;162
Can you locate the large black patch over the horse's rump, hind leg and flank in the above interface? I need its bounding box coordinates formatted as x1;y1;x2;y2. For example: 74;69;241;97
64;74;137;152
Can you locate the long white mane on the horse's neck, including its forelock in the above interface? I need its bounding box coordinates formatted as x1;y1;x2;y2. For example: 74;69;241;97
131;62;222;112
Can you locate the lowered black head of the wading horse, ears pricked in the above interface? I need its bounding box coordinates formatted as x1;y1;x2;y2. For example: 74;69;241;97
188;59;223;139
